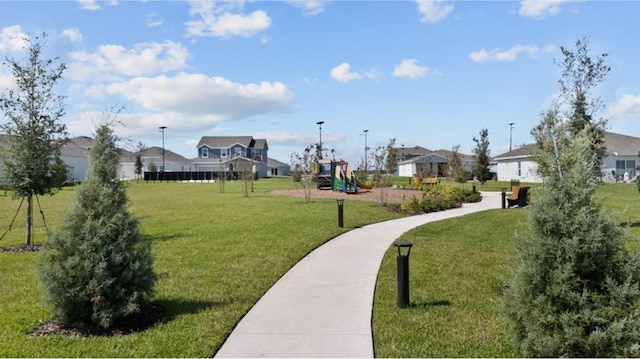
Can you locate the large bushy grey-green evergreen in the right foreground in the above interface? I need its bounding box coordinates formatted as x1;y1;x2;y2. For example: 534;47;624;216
507;124;640;357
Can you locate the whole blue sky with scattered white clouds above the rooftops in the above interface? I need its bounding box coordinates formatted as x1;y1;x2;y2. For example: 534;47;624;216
0;0;640;165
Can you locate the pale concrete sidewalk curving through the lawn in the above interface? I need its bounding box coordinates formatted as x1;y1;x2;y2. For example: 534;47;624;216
215;192;502;358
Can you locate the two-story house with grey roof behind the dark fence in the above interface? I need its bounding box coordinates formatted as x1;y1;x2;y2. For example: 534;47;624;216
192;136;269;177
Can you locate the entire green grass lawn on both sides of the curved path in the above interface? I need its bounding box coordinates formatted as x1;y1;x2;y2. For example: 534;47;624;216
5;178;640;357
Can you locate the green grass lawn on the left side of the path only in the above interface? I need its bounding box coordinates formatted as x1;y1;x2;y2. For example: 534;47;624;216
0;178;399;357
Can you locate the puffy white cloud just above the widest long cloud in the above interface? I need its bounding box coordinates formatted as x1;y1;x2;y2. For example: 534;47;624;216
67;40;189;82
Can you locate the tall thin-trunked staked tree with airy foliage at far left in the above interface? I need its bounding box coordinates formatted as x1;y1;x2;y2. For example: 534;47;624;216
0;33;68;245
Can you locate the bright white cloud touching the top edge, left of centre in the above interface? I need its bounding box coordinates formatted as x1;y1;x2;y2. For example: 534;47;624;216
185;0;271;39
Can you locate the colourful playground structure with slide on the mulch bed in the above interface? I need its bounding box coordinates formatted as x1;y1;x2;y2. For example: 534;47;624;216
314;160;372;194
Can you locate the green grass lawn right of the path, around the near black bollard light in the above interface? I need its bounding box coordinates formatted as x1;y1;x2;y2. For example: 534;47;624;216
373;184;640;357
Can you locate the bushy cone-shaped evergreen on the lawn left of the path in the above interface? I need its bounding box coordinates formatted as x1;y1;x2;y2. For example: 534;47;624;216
39;125;156;328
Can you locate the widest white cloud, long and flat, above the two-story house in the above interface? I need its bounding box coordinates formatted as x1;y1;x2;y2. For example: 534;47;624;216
103;73;293;123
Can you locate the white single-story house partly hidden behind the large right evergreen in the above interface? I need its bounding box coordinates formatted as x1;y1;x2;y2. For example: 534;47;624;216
494;131;640;182
